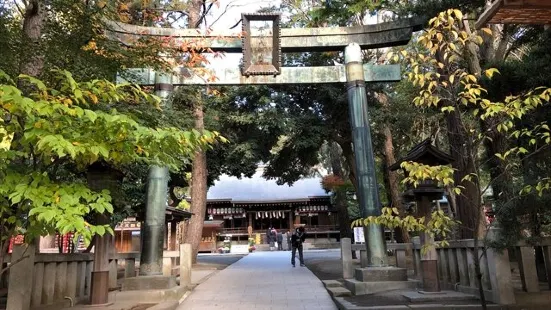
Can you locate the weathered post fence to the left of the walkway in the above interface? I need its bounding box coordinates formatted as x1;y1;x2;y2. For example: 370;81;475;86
7;245;191;310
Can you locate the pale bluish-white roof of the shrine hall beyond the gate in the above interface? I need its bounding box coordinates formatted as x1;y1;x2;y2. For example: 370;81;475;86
207;169;329;203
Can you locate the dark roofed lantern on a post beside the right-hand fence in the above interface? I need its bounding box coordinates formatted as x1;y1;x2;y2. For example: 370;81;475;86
389;138;453;292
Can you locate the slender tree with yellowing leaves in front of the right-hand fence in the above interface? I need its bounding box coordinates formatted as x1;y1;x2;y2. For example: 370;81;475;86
386;9;551;307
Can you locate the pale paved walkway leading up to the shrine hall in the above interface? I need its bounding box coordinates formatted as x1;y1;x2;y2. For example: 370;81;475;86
178;251;337;310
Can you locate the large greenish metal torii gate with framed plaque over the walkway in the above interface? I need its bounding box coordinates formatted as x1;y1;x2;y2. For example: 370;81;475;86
109;14;422;275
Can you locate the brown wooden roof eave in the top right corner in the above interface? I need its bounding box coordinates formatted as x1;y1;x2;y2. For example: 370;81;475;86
476;0;551;28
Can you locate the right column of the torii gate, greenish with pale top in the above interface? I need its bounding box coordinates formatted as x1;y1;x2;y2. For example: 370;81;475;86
344;43;388;267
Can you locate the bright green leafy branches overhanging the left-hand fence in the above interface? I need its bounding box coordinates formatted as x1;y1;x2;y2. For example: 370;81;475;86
0;71;223;245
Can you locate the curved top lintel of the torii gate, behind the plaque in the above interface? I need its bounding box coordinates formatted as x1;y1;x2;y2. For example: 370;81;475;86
107;18;422;53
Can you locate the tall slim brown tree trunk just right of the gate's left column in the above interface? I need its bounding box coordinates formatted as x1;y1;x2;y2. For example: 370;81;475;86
185;0;207;263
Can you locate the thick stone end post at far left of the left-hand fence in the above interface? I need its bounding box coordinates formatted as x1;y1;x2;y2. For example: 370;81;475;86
7;244;36;310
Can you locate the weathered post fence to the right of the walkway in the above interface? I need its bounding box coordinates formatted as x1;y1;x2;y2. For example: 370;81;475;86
341;232;551;305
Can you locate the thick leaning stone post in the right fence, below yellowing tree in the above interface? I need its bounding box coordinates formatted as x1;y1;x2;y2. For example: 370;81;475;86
486;227;516;305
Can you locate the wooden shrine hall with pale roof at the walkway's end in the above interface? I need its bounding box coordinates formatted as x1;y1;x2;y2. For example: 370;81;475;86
205;166;338;237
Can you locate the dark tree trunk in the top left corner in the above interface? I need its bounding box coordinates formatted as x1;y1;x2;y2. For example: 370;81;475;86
19;0;46;77
